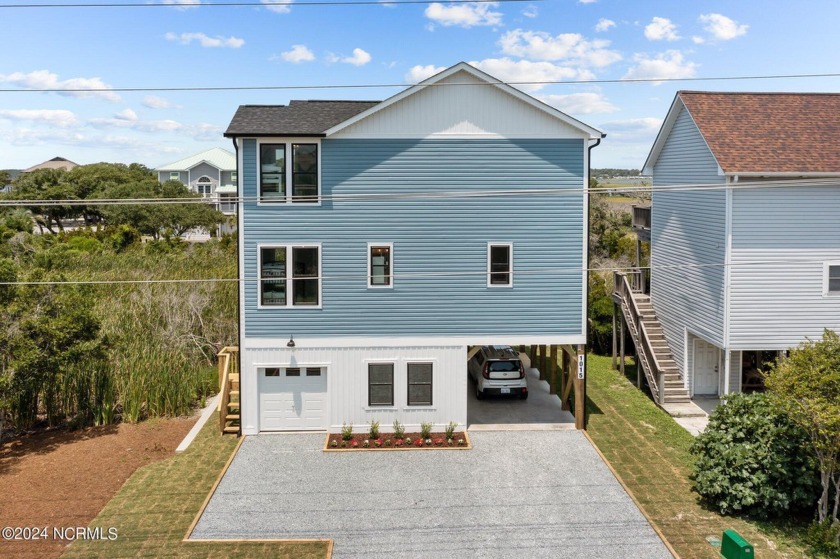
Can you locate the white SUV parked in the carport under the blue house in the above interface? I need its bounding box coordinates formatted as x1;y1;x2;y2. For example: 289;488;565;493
467;346;528;400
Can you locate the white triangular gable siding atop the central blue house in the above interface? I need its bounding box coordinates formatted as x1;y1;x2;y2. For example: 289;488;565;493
330;71;588;138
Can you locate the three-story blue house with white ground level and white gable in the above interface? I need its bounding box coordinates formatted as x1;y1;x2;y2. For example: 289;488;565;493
225;63;602;434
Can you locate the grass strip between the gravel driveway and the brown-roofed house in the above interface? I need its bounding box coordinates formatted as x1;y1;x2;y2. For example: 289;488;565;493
587;355;811;559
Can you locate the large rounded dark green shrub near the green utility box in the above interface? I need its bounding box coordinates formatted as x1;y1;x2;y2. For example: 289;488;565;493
691;394;819;518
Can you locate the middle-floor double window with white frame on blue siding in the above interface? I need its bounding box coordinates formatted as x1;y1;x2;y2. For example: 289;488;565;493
258;244;321;308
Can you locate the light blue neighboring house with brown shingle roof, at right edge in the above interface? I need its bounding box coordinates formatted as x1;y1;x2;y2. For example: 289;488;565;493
628;91;840;397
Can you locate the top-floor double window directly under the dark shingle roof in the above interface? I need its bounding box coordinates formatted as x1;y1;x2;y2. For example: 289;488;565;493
259;139;321;204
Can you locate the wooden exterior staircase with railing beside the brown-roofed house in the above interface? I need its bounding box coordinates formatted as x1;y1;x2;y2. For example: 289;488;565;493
613;272;691;405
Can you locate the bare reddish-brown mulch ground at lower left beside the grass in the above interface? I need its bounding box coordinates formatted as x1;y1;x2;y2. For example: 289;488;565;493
0;417;197;558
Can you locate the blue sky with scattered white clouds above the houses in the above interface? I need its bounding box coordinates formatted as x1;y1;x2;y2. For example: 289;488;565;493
0;0;840;168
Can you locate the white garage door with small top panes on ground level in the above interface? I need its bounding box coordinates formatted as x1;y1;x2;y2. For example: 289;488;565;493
259;367;327;431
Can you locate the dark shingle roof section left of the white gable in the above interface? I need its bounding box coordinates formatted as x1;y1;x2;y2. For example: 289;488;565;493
225;101;379;137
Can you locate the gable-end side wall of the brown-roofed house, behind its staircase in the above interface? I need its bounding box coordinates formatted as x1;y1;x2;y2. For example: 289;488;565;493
651;103;726;382
